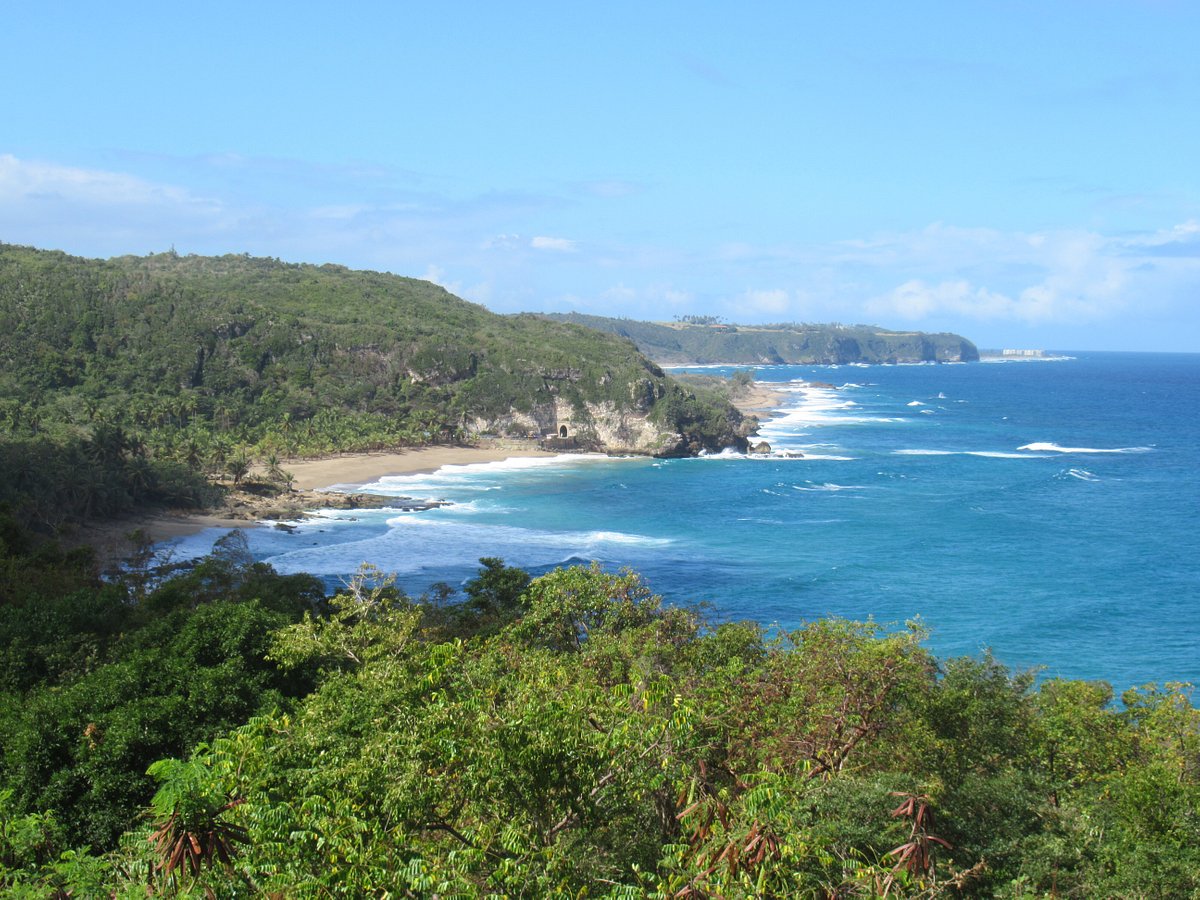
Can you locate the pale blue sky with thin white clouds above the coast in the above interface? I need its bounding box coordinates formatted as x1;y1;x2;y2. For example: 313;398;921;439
0;0;1200;352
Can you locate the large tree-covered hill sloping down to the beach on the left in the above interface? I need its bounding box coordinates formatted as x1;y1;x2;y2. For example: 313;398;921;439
0;245;743;527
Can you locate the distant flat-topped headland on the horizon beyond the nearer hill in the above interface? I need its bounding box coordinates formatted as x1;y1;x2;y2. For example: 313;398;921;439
547;313;979;365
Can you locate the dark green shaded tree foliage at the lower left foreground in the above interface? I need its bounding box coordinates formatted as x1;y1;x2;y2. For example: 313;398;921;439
0;520;322;846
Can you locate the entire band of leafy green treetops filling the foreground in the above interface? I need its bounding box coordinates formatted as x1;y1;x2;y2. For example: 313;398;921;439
0;522;1200;898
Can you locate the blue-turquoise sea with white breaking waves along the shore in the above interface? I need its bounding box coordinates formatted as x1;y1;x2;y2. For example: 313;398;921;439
171;353;1200;691
